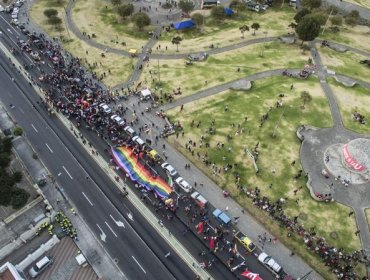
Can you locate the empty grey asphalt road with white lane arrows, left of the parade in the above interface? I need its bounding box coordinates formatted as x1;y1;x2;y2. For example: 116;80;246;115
0;8;273;279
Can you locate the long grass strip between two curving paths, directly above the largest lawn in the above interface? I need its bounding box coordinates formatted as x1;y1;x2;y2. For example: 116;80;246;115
140;41;309;98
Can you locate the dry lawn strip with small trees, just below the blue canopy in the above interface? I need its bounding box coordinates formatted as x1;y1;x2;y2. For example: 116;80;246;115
153;8;294;54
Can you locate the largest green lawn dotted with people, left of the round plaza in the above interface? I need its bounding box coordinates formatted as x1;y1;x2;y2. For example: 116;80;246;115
167;76;363;279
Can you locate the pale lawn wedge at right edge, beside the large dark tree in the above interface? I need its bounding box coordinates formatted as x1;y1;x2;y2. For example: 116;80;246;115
319;24;370;52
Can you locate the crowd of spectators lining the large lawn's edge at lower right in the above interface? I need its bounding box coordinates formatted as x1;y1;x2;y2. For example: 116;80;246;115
178;116;368;280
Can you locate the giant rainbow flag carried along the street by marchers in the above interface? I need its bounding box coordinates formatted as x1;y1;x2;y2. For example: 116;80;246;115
111;147;173;198
